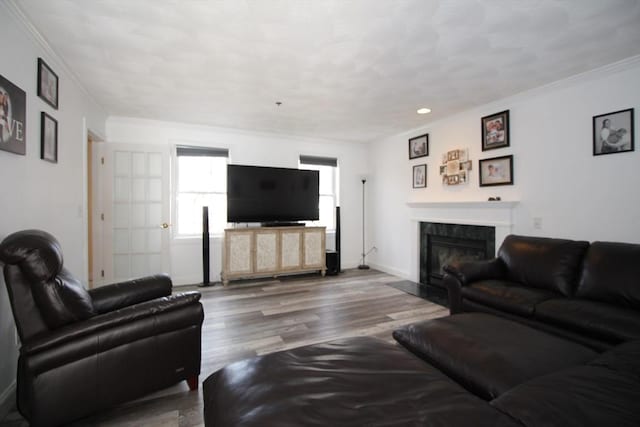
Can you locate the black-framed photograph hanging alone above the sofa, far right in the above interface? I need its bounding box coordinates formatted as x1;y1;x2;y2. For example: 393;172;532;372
593;108;634;156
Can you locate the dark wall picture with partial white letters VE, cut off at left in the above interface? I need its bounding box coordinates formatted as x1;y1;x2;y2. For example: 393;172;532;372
0;75;27;156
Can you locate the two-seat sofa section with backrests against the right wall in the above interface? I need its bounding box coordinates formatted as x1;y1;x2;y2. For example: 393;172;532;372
444;235;640;350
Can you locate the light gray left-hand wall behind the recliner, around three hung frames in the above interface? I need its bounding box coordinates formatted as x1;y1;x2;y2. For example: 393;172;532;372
0;2;106;418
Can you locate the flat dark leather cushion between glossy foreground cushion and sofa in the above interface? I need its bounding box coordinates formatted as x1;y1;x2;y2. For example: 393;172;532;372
393;313;597;400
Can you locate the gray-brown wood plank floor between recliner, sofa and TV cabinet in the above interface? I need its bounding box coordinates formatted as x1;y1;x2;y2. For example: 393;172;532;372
0;270;448;427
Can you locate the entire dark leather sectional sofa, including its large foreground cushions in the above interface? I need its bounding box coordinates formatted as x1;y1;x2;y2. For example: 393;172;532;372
203;236;640;427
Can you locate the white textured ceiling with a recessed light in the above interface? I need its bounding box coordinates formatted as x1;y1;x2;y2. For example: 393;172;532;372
14;0;640;141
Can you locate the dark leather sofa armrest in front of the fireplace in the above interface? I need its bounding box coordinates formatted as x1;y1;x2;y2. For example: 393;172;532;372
443;258;506;314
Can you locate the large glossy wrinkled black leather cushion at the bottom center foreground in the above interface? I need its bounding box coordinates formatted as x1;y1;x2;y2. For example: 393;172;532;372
203;337;517;427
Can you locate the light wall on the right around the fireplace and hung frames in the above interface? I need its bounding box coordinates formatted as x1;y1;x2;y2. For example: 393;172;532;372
370;57;640;279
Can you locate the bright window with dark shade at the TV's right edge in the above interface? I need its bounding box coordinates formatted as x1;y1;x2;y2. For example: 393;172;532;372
299;156;338;231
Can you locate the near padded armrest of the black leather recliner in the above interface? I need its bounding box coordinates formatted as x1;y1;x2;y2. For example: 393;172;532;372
20;292;204;361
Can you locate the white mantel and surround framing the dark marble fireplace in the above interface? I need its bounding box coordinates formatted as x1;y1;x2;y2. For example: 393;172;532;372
407;201;519;282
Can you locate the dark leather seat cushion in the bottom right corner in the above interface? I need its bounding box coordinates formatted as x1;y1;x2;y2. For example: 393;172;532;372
491;342;640;427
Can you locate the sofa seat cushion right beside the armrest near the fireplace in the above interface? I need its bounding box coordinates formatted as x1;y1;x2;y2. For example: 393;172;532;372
461;280;560;316
